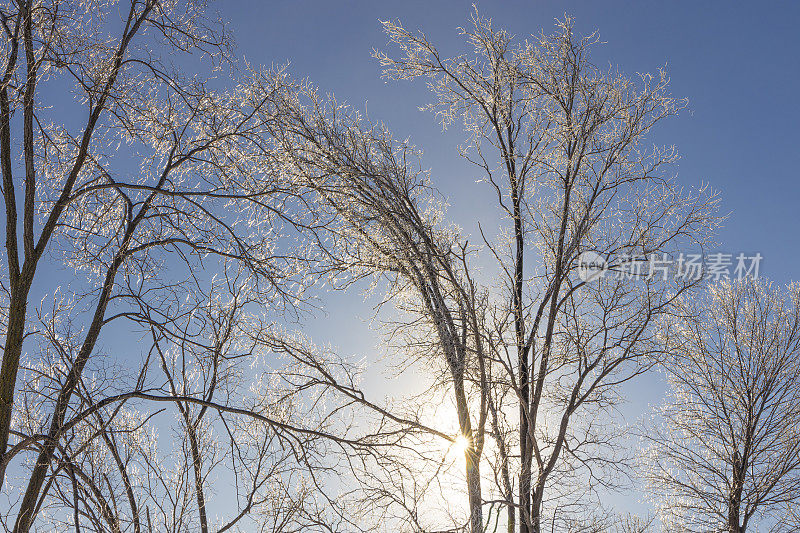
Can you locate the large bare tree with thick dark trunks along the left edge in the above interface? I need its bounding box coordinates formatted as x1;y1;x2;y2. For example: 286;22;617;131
0;0;368;532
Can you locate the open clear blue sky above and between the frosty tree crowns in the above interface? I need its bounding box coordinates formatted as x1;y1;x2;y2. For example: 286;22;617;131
212;0;800;520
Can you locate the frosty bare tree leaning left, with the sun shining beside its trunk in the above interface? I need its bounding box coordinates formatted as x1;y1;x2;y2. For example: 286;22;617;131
260;74;488;531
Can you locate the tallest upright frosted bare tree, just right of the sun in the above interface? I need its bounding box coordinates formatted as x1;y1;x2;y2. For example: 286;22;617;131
375;13;716;533
